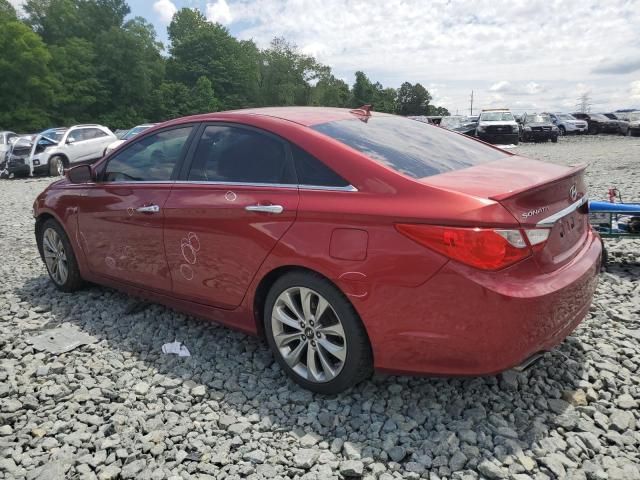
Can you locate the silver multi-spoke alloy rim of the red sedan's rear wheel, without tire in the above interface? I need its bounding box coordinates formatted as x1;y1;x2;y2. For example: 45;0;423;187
271;287;347;383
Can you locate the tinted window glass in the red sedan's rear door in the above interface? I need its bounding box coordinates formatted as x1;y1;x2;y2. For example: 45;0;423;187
188;125;295;184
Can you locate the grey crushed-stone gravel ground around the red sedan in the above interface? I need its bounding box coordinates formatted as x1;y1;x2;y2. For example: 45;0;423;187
0;132;640;480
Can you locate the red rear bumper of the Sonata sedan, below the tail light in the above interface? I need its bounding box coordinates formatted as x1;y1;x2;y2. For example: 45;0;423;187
363;231;602;375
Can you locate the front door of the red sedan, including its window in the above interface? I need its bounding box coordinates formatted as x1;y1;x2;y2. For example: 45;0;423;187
78;126;193;293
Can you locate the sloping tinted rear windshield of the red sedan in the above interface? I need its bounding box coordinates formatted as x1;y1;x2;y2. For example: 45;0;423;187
312;116;510;178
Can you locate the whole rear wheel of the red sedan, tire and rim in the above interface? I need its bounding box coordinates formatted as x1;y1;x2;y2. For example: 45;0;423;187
264;272;373;394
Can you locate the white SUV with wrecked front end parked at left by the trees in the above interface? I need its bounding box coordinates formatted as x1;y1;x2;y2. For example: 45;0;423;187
29;124;117;176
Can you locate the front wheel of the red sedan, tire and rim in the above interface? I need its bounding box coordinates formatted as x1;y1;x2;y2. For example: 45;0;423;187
38;219;84;292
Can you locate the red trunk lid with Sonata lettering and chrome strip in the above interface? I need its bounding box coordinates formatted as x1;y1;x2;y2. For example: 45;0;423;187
422;156;589;271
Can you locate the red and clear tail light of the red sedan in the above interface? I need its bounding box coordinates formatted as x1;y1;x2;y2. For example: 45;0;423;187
396;223;531;270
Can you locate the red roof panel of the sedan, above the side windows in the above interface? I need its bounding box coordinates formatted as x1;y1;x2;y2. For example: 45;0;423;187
182;107;389;126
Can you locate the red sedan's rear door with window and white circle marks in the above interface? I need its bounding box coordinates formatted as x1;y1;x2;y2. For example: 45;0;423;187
163;123;298;309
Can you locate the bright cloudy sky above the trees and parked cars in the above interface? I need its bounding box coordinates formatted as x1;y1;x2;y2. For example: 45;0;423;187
12;0;640;114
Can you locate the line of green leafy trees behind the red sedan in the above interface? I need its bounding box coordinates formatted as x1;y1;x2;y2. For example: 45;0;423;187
0;0;448;132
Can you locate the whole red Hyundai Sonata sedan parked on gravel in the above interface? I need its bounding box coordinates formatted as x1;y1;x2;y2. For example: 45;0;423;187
34;107;602;393
